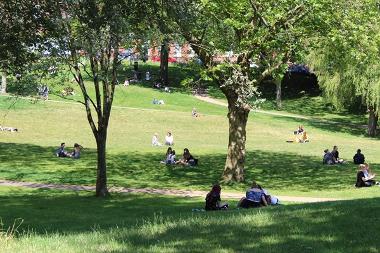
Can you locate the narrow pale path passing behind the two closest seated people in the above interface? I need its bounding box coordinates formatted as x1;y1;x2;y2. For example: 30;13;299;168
0;180;341;203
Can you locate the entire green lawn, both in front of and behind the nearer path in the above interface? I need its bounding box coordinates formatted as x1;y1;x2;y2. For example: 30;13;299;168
0;65;380;253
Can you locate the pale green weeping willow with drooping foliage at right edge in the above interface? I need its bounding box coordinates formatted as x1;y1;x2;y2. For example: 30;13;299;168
309;0;380;137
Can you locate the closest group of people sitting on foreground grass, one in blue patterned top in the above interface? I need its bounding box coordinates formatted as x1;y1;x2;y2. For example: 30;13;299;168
205;181;280;211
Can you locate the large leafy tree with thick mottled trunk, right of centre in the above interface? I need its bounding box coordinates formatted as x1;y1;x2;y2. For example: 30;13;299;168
167;0;330;182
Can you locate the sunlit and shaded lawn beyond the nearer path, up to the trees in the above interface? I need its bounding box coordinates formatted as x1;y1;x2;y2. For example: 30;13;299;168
0;86;380;198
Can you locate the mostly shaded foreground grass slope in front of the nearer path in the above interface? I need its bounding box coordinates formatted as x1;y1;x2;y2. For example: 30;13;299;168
0;187;380;253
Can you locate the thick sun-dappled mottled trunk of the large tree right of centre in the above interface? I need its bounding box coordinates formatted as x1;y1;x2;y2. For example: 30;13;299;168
223;97;250;182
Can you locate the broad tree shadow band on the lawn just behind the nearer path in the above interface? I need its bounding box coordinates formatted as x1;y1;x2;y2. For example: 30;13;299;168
0;142;362;192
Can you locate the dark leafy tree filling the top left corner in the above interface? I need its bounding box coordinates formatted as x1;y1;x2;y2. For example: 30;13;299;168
0;0;52;93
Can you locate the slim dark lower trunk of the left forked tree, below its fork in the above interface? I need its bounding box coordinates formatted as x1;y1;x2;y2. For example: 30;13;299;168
96;130;109;197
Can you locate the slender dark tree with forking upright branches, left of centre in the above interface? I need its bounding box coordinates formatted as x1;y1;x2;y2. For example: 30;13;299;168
51;0;150;197
